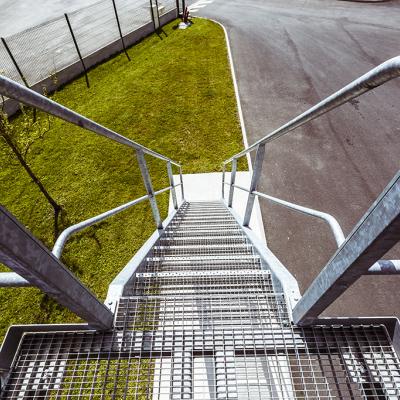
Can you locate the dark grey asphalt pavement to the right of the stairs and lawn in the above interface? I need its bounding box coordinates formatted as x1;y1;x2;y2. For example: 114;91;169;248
196;0;400;316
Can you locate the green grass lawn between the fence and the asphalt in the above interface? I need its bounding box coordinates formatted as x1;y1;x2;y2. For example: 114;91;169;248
0;19;244;337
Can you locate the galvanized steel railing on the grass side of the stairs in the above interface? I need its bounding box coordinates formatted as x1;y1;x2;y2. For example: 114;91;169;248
0;75;184;326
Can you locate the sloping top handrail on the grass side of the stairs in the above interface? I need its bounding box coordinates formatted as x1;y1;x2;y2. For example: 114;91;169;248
0;75;181;167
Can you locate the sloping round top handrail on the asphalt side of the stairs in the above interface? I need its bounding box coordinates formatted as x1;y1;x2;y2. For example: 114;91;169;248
224;56;400;164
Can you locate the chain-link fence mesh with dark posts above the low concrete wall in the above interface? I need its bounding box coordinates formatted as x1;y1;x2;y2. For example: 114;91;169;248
0;0;180;108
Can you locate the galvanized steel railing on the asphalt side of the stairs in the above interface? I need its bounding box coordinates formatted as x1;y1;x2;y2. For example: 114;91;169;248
222;56;400;323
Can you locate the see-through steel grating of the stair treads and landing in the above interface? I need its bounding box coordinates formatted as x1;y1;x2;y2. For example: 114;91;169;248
1;203;400;400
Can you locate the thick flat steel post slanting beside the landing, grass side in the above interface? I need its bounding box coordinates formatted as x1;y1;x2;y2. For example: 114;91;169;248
0;206;114;329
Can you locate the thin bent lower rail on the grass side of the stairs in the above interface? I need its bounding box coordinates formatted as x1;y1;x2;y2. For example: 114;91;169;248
51;183;181;258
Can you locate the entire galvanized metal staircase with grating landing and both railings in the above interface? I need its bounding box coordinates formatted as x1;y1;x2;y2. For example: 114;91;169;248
0;57;400;400
